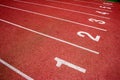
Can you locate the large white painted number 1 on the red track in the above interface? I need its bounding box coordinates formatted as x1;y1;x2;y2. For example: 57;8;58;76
55;57;86;73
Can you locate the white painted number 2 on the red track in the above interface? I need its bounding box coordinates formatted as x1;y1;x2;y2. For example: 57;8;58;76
77;31;100;42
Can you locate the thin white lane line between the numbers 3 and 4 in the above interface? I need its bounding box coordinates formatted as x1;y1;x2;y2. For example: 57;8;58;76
14;0;110;19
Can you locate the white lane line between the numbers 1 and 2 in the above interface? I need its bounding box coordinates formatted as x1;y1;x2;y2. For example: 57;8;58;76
0;19;99;54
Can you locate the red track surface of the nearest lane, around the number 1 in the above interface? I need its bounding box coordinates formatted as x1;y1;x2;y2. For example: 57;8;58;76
0;22;119;80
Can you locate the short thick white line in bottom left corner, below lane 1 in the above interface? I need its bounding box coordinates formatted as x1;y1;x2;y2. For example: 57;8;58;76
0;58;34;80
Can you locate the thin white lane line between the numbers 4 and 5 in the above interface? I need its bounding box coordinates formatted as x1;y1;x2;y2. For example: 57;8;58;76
46;0;112;12
